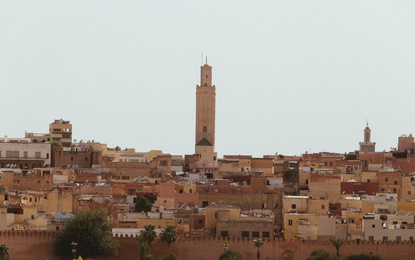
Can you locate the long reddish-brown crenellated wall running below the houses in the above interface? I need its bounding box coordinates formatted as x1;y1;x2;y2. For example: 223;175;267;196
0;231;415;260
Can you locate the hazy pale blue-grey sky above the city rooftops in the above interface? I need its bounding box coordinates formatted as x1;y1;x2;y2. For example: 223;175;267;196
0;0;415;156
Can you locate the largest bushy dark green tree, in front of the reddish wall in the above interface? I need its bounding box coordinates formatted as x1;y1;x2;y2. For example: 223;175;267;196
54;210;119;258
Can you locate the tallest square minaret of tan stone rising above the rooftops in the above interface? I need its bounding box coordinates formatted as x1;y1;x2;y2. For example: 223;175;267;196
195;60;217;161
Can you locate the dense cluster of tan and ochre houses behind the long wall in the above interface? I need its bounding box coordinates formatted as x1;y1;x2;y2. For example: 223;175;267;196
0;120;415;241
